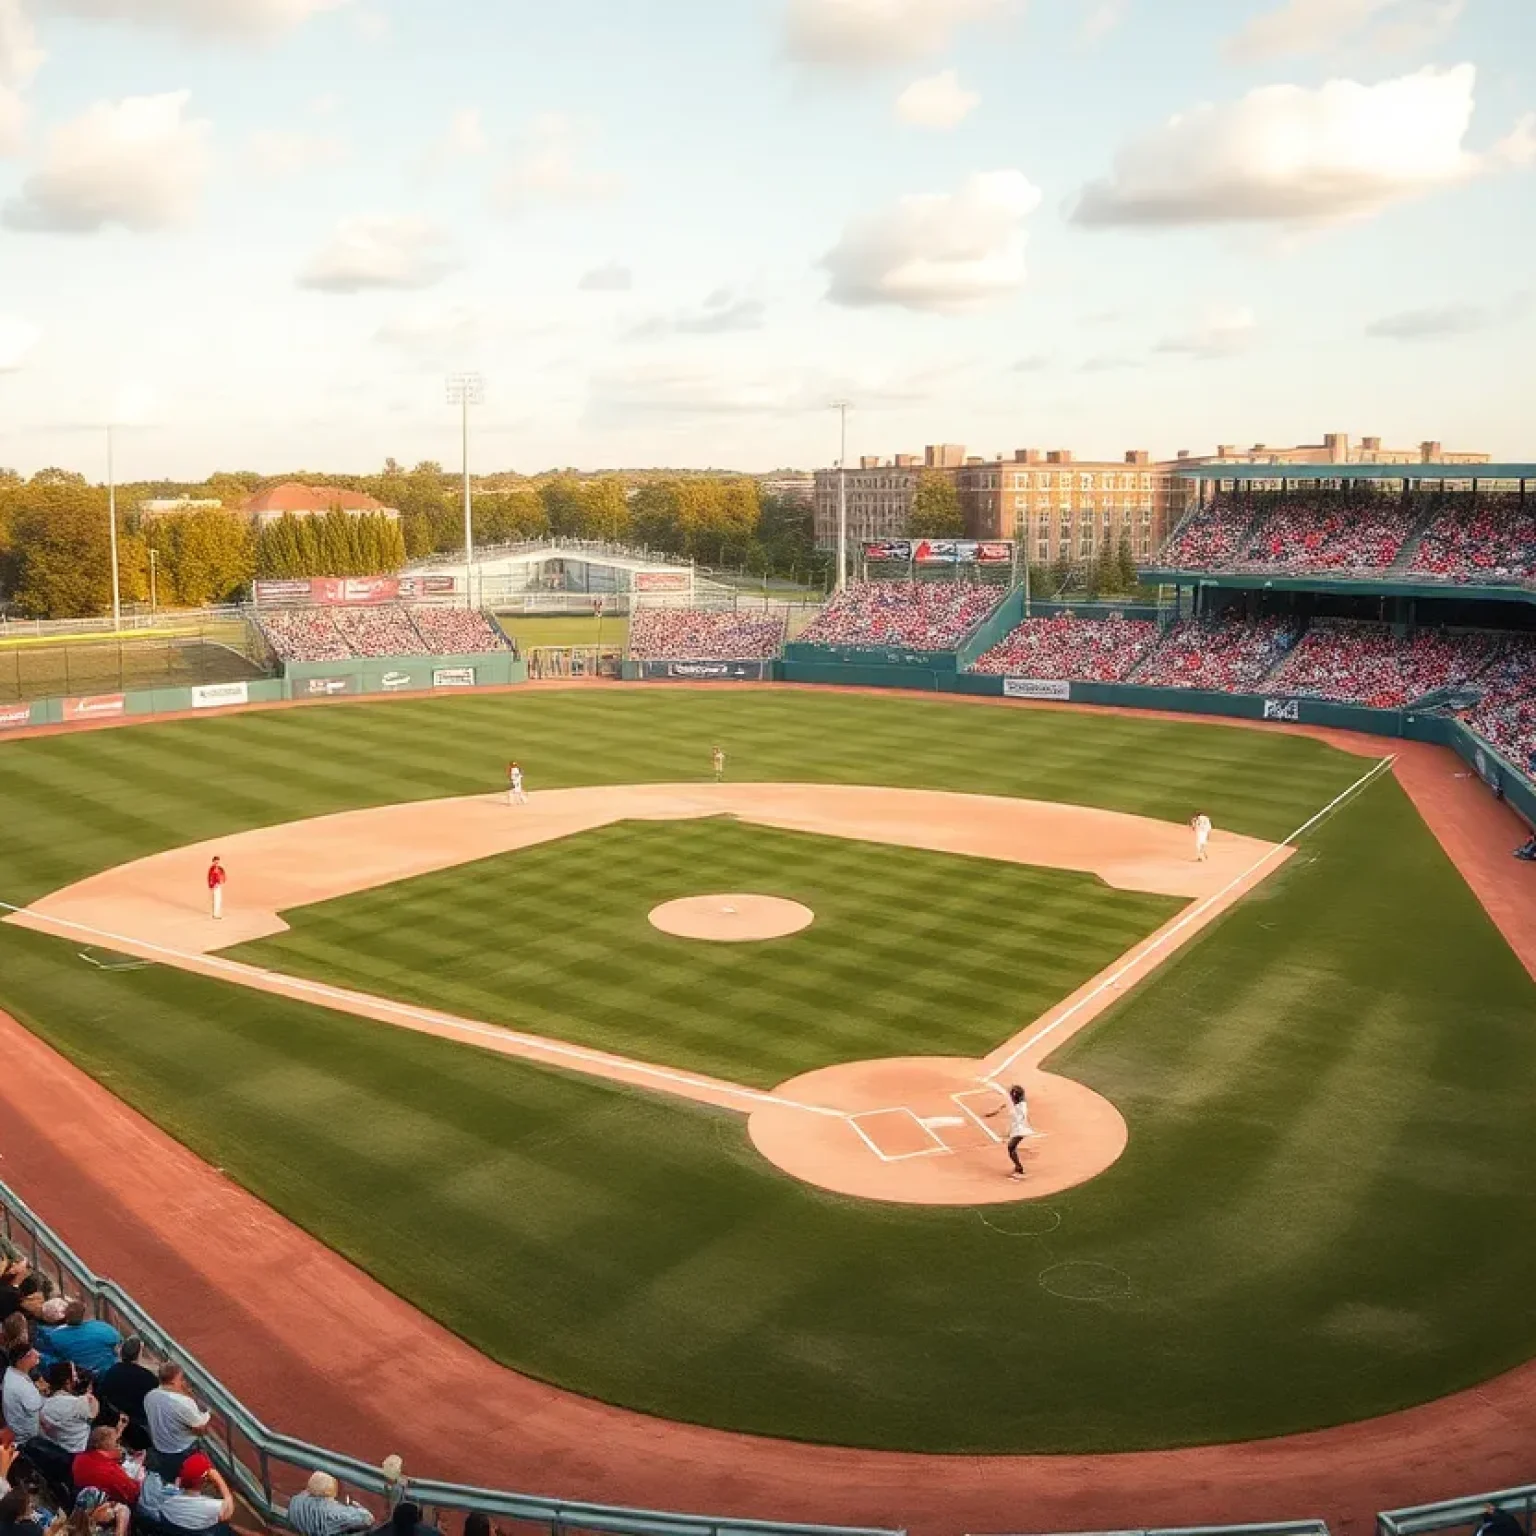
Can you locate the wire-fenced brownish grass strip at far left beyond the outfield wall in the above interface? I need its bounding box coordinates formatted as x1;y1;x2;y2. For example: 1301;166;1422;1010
0;622;272;702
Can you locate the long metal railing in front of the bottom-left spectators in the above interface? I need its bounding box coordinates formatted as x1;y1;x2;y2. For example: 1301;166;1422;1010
0;1183;906;1536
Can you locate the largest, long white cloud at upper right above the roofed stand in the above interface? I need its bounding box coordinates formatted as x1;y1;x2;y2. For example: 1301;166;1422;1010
1072;65;1536;226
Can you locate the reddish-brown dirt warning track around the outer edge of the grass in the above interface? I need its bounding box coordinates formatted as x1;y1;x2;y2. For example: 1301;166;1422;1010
0;697;1536;1536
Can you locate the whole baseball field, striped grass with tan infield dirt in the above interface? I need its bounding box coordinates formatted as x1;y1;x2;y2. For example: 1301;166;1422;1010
0;688;1536;1452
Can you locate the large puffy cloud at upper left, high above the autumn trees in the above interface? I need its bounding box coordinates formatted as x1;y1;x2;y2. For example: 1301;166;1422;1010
0;91;212;235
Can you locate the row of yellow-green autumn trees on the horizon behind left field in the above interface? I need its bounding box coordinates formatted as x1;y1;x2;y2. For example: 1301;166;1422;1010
0;461;828;619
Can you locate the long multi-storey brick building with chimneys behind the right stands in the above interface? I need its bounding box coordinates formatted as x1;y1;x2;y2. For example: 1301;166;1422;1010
816;433;1488;564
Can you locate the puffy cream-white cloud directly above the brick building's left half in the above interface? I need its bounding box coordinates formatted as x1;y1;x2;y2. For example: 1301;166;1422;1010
822;170;1040;313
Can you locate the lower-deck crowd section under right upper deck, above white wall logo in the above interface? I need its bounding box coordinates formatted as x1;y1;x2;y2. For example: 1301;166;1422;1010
1269;619;1504;710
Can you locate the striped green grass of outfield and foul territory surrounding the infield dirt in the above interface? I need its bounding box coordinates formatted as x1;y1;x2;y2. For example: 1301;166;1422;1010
0;690;1536;1452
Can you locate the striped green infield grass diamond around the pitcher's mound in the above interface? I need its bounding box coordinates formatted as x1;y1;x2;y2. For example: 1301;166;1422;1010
229;817;1184;1087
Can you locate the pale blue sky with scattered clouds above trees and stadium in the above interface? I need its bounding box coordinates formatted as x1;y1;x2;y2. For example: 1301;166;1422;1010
0;0;1536;479
